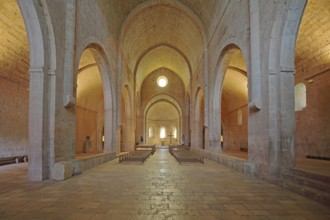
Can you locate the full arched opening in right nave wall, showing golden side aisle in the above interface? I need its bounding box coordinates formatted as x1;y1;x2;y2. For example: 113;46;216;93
220;49;248;155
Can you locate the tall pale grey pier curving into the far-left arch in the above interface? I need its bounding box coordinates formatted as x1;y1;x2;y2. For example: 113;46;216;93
17;0;56;181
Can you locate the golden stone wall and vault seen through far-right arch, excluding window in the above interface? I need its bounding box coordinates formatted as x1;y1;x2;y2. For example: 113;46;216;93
295;0;330;157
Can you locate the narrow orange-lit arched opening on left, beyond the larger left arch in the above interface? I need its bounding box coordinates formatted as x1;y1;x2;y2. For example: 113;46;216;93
120;85;134;151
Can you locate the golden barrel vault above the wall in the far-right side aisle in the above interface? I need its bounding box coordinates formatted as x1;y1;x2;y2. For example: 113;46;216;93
295;0;330;77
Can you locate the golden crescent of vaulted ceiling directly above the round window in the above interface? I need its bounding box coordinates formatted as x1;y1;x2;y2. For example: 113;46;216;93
136;46;190;88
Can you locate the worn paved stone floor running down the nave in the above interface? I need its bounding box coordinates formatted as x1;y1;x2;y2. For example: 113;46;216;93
0;149;330;220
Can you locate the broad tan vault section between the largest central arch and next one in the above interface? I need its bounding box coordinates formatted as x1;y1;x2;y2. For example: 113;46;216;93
121;4;204;83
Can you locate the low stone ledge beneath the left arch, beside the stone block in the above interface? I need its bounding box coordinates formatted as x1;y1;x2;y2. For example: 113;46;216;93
72;153;116;175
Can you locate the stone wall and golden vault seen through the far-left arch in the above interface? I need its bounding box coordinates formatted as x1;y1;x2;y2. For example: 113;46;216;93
0;0;30;158
